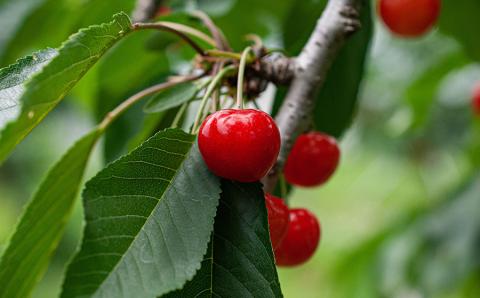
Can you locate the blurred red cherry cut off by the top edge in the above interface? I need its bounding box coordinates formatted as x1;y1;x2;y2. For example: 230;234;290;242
378;0;442;37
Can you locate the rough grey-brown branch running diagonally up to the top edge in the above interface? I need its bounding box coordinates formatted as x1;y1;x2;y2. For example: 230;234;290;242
262;0;361;192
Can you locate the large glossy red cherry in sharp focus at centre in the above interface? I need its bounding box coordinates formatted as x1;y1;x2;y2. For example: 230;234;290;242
198;109;280;182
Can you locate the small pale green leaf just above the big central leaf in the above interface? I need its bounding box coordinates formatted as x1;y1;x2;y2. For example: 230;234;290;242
143;82;198;113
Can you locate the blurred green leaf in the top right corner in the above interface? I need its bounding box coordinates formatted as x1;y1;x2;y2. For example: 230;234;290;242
439;0;480;61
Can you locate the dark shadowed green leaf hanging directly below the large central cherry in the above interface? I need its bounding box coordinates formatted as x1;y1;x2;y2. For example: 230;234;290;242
166;180;282;297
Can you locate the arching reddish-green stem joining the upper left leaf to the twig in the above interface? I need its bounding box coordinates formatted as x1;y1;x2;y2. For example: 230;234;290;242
133;22;216;56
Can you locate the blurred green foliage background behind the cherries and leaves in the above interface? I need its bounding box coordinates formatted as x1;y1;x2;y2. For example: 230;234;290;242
0;0;480;298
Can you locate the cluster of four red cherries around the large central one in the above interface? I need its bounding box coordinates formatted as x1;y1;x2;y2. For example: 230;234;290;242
198;109;340;266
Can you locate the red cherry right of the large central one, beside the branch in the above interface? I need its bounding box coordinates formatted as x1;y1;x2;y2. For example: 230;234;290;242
284;132;340;187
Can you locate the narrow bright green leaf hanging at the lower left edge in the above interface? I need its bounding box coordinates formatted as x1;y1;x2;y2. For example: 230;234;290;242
0;130;100;298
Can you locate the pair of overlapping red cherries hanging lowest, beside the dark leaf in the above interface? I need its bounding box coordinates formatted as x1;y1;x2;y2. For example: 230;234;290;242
265;193;321;266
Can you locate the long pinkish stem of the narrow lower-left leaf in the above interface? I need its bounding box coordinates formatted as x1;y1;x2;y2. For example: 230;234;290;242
98;76;200;131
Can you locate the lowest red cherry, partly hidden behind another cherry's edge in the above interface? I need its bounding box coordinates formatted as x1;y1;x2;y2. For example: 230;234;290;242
275;209;321;267
